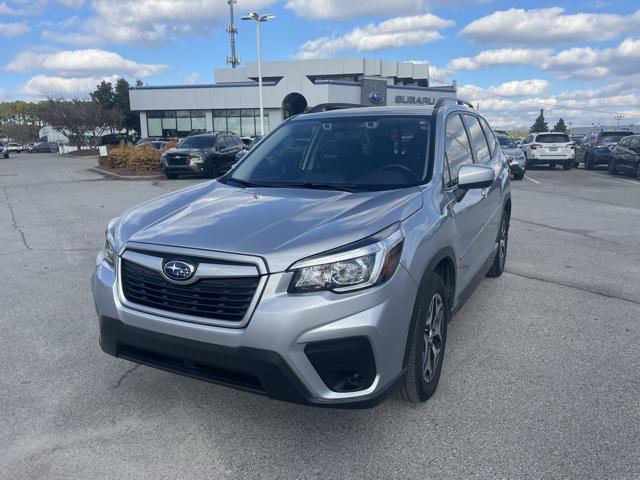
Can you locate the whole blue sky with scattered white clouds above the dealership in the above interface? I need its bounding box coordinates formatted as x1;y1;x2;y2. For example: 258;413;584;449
0;0;640;126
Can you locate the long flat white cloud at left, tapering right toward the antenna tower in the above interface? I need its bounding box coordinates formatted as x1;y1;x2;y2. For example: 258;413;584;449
5;49;168;77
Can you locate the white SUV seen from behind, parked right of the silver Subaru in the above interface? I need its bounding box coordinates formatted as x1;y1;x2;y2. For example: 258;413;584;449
520;132;576;170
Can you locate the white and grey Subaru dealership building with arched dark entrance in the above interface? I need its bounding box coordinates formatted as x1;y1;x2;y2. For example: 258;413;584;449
130;58;456;137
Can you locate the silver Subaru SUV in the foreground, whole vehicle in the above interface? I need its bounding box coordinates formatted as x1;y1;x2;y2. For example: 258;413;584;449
92;99;511;407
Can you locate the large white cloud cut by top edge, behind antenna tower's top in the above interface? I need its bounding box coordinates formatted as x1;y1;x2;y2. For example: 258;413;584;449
42;0;275;47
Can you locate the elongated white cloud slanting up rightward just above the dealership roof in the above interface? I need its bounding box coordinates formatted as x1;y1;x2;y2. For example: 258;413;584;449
296;13;454;59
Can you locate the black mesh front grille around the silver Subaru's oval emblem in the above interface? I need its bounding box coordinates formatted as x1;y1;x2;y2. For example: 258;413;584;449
120;259;260;322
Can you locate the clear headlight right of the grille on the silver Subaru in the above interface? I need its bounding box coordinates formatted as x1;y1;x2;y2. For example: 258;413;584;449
288;223;404;293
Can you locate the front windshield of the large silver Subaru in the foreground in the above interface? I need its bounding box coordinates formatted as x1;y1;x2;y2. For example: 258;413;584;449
225;116;432;191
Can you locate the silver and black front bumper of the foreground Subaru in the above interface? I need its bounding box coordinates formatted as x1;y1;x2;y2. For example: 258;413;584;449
92;248;417;408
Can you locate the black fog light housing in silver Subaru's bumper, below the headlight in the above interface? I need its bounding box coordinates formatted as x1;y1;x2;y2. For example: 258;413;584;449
304;337;376;393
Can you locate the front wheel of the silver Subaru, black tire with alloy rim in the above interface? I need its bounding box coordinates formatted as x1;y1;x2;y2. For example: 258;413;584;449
396;273;451;403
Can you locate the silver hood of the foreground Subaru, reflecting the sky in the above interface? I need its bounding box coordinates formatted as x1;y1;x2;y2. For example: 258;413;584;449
115;181;423;272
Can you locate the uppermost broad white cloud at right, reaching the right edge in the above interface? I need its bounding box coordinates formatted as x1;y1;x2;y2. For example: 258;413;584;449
460;7;640;46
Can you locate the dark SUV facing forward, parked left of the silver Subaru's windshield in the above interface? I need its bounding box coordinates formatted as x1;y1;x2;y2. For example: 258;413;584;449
160;132;244;178
